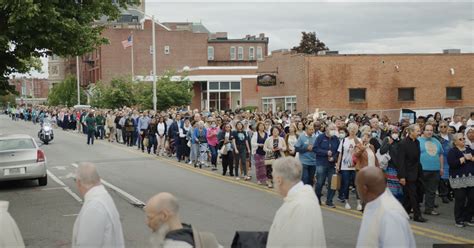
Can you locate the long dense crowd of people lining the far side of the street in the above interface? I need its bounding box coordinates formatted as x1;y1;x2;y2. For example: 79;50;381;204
3;106;474;227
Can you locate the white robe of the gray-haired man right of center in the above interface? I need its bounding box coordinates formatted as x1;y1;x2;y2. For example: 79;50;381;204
267;182;326;247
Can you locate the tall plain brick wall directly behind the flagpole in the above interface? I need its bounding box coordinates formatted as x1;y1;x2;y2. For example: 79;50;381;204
100;21;207;82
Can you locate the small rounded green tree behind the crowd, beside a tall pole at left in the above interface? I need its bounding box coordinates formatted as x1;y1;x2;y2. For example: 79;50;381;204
48;76;87;106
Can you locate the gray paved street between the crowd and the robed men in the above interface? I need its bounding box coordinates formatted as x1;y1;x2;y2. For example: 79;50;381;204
0;115;474;247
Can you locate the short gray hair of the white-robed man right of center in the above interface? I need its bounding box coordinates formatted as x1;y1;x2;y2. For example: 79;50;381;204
273;156;303;183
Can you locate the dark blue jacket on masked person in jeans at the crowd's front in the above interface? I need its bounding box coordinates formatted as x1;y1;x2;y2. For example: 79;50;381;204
313;134;339;166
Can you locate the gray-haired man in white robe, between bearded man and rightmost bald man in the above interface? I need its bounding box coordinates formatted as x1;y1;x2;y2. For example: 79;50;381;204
267;157;326;247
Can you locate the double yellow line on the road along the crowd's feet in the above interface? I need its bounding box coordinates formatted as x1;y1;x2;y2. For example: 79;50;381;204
65;130;474;244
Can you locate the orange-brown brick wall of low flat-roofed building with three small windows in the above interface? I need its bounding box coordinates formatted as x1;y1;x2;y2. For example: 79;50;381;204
306;54;474;114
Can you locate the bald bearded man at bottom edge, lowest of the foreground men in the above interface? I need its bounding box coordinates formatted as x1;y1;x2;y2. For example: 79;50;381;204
145;192;221;248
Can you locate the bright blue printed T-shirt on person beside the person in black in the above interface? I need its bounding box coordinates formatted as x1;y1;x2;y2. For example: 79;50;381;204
418;137;444;171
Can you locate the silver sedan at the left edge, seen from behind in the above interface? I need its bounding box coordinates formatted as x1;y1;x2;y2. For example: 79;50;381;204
0;134;48;186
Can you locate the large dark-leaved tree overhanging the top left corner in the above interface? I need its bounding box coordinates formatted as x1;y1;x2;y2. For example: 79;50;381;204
0;0;140;95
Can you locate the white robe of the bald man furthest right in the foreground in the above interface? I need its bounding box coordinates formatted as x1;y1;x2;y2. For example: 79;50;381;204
356;189;416;247
